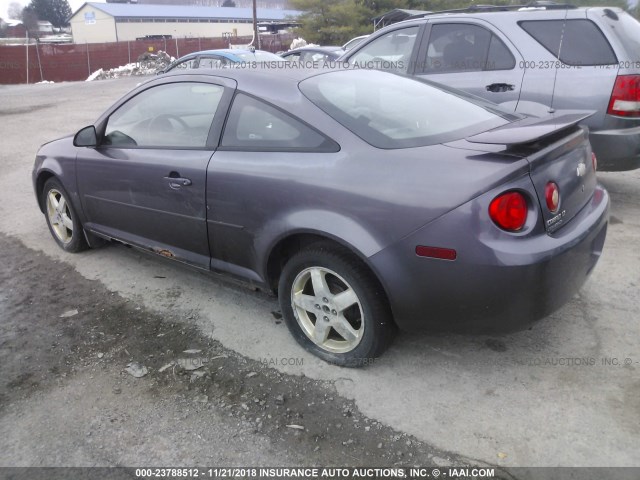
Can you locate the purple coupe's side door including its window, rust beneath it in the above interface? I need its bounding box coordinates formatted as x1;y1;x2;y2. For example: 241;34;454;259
77;77;235;268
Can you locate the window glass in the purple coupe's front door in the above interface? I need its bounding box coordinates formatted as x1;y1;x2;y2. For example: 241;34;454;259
102;82;224;148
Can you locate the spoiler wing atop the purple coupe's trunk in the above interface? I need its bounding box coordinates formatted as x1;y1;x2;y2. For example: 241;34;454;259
467;110;595;145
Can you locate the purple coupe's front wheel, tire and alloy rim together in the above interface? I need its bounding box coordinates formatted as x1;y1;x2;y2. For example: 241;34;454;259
42;178;87;253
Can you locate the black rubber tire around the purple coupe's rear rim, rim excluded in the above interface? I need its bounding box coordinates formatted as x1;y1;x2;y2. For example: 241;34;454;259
278;247;391;367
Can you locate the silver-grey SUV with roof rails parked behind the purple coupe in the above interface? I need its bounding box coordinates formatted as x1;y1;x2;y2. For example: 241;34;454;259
340;5;640;170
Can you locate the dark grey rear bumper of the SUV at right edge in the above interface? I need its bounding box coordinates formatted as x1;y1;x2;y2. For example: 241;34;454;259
589;127;640;172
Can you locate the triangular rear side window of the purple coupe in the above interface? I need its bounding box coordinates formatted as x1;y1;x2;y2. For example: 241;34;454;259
221;93;340;152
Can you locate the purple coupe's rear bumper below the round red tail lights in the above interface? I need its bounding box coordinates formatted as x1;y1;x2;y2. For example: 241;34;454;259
370;186;609;333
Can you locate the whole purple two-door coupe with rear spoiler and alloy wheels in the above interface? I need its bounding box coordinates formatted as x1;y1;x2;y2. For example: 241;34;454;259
33;69;609;366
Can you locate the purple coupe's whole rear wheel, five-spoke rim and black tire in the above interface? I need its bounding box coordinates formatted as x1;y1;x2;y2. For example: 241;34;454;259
278;244;395;367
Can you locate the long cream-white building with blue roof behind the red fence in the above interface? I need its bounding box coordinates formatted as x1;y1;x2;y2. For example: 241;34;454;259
69;2;300;43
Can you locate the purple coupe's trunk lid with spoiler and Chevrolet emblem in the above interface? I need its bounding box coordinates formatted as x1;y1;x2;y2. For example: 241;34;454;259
467;112;597;234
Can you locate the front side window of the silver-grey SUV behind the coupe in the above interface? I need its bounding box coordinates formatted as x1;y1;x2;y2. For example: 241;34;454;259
349;27;419;72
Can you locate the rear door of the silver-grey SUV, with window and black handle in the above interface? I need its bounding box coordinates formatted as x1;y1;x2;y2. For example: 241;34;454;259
410;19;524;110
